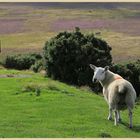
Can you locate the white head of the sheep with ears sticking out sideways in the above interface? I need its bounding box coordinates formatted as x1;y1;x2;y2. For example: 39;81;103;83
90;64;109;82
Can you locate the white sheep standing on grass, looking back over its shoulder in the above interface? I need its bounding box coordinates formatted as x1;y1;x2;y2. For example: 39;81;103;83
90;64;136;128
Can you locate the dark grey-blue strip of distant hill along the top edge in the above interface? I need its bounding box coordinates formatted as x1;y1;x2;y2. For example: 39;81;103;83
7;2;140;9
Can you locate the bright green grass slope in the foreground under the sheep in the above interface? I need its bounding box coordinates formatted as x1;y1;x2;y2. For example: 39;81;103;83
0;69;140;138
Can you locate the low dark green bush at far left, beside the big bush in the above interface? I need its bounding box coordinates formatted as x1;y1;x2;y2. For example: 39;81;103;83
4;54;42;70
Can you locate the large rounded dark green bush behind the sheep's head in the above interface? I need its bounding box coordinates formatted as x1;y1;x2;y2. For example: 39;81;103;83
44;28;112;86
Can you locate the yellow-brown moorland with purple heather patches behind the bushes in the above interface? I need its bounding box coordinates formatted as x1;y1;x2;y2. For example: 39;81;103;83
0;3;140;62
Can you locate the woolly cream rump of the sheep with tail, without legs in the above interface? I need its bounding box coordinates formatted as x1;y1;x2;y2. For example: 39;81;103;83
107;79;136;110
